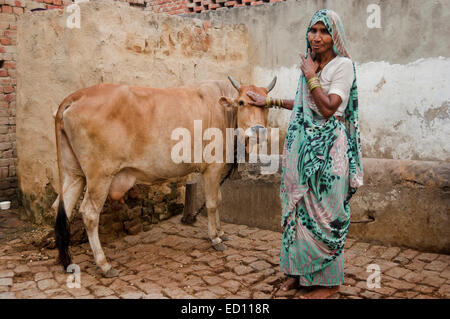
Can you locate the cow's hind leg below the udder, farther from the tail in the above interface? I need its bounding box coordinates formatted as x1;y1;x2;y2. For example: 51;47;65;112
80;180;118;277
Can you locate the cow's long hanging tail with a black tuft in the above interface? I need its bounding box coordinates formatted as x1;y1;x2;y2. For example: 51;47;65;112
55;95;73;269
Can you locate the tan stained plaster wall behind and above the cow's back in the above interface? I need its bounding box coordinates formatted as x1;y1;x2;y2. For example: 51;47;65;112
17;1;251;222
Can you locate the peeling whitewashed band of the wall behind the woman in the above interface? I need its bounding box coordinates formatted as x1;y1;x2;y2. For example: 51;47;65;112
252;57;450;161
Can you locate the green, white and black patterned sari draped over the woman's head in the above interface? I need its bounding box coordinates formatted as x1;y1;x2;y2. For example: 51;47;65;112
280;10;363;286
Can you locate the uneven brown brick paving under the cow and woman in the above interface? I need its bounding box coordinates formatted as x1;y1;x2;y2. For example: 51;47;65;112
0;216;450;299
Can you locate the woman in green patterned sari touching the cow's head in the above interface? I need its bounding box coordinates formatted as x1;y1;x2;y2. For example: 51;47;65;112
248;10;363;298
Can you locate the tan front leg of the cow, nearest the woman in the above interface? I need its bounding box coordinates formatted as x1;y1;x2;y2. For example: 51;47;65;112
203;165;226;251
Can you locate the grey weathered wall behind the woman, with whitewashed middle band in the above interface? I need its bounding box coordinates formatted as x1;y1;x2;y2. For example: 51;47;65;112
196;0;450;253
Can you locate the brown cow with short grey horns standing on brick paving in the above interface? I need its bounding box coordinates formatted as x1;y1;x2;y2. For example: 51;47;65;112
53;78;276;277
